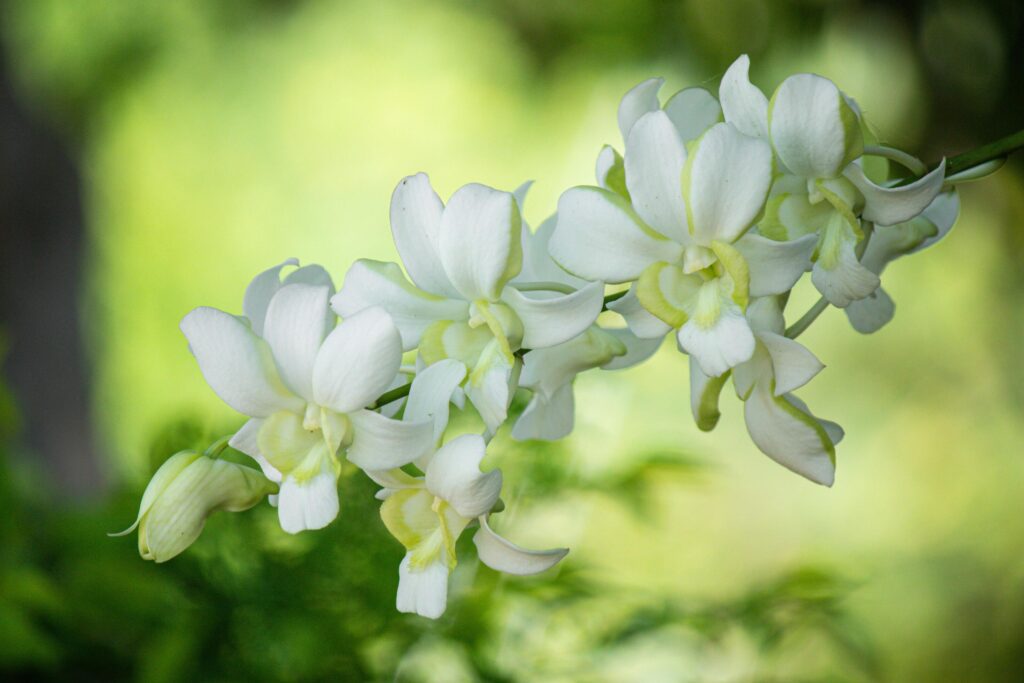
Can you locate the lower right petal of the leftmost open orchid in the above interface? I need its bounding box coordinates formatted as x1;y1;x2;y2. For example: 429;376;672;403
347;411;434;470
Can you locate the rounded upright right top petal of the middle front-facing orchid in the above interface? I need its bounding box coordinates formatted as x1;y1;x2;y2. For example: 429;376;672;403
438;183;522;301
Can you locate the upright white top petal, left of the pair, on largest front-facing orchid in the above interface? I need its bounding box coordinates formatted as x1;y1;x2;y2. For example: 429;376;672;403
626;111;689;244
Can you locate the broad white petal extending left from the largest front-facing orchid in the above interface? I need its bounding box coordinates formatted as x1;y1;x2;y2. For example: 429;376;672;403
549;187;682;283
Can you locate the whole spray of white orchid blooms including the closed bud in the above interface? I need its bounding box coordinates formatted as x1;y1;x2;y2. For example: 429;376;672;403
116;55;959;617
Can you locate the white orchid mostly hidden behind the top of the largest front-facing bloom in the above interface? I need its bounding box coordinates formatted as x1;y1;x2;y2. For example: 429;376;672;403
595;78;722;199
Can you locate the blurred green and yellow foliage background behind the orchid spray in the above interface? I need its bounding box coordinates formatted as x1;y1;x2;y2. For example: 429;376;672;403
0;0;1024;682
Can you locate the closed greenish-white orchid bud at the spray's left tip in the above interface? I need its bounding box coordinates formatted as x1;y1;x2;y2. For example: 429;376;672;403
111;451;278;562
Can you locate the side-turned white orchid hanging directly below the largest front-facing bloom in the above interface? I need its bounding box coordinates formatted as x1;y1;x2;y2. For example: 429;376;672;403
690;297;843;486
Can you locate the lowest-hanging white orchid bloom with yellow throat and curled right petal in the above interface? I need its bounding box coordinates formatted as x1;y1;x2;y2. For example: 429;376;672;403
368;434;568;618
